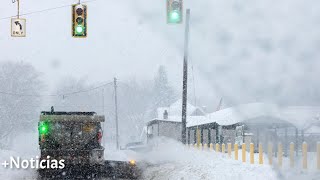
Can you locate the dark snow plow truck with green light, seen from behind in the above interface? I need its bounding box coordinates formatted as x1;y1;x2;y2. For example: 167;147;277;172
37;108;140;180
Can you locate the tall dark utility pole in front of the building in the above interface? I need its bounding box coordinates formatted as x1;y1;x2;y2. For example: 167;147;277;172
181;9;190;144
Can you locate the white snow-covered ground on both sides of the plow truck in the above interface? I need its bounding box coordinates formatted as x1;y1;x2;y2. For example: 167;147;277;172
0;134;320;180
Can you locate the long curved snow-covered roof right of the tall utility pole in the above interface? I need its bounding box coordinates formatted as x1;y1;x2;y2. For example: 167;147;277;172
188;103;320;128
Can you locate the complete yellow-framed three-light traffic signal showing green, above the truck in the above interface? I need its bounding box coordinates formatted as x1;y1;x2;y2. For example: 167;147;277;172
72;4;87;38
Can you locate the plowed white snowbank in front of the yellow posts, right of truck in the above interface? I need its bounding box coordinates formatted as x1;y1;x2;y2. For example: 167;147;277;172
143;140;278;180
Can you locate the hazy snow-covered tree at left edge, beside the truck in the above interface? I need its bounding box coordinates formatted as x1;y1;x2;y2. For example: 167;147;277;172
0;62;44;148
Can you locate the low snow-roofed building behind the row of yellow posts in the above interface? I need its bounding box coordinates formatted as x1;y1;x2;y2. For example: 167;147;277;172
147;100;320;154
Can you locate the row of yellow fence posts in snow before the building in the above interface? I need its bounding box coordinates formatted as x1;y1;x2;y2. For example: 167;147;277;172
188;142;320;170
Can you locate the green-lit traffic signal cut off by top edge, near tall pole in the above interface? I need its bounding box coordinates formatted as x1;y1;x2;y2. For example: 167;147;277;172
167;0;183;24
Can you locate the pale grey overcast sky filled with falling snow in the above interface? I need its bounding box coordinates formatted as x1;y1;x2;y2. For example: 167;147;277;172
0;0;320;107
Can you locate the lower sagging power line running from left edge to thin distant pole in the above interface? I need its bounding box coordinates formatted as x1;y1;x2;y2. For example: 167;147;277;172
0;82;113;97
